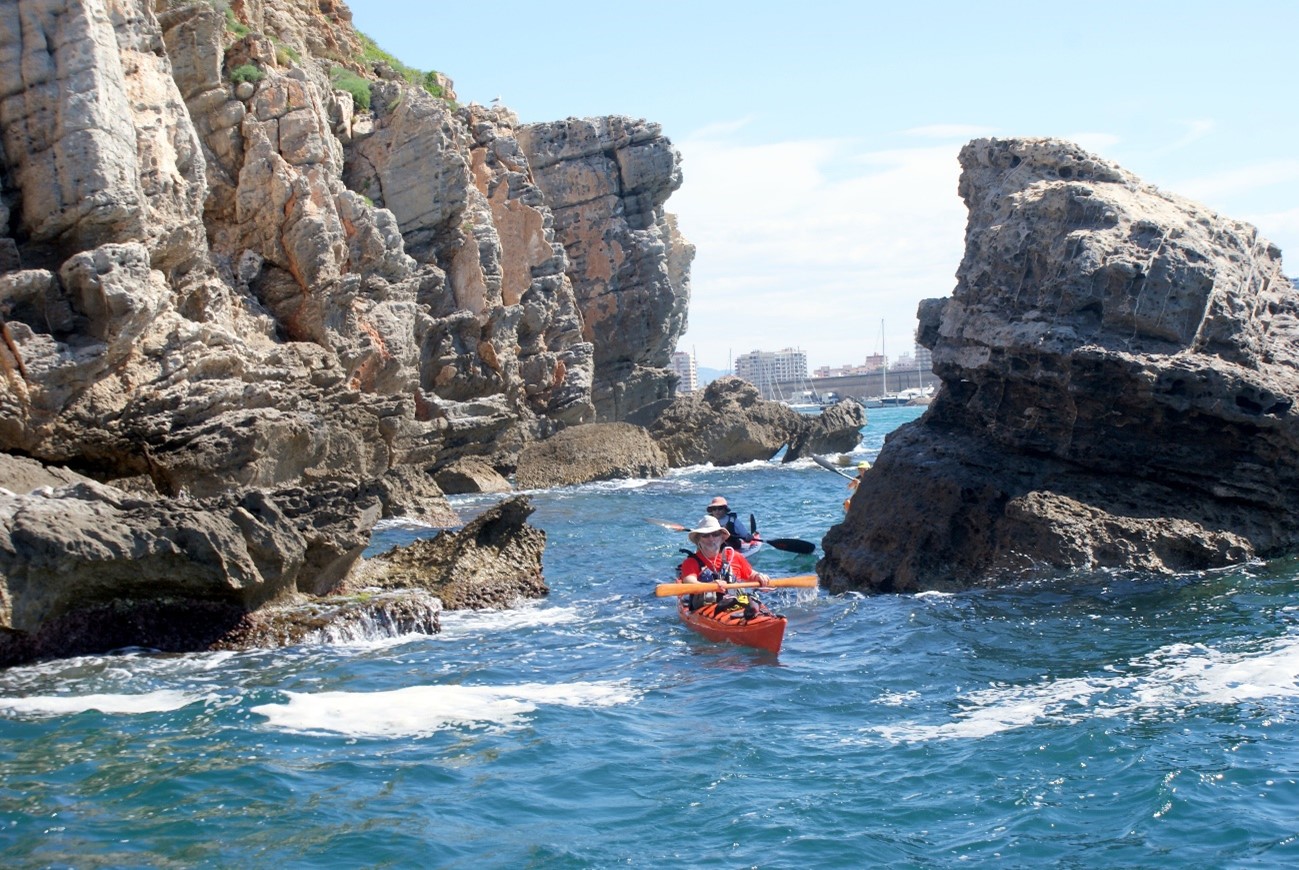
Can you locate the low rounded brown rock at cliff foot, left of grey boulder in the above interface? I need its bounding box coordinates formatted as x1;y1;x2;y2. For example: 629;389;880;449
514;423;668;490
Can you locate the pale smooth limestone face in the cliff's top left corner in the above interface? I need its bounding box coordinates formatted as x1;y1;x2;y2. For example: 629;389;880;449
0;0;205;271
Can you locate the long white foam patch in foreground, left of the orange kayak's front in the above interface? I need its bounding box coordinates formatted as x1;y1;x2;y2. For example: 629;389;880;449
252;682;637;738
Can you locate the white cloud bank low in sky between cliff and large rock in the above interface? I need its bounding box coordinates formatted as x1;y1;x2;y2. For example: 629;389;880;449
668;136;965;367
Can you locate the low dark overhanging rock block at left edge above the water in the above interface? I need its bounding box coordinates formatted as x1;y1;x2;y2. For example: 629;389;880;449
0;472;309;664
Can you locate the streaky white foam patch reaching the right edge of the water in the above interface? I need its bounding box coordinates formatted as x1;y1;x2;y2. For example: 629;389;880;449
869;638;1299;743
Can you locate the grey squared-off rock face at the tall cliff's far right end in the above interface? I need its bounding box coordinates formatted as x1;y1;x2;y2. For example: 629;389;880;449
518;116;694;419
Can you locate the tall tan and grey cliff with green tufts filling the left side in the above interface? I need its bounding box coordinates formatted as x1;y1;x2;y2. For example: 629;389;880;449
0;0;690;664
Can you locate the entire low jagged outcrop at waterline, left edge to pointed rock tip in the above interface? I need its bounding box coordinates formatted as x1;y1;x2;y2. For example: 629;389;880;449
0;457;535;666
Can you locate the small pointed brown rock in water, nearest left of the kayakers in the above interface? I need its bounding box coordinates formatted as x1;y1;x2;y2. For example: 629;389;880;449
348;496;549;610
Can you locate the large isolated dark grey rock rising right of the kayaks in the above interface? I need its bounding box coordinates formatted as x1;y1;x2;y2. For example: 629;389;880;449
817;139;1299;592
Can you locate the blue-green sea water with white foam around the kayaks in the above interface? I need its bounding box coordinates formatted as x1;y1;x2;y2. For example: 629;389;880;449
0;409;1299;867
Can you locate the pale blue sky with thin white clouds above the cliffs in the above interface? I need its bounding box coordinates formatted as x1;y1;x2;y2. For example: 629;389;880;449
348;0;1299;369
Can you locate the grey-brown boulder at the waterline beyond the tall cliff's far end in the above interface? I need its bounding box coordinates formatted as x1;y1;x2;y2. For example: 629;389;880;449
650;378;805;467
